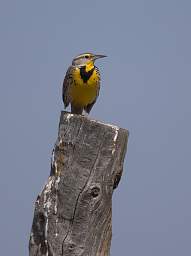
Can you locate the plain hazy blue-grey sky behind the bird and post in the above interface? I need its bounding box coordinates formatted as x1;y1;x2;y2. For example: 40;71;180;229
0;0;191;256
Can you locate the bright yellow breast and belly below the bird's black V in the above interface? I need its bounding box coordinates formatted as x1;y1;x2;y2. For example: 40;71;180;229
70;68;99;107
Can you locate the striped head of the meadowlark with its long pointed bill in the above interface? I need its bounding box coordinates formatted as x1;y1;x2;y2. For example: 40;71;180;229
72;53;106;69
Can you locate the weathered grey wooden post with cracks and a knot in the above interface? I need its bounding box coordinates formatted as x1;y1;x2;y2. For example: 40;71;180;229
29;112;128;256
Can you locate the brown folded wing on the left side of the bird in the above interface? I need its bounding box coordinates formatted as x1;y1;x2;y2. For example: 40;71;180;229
62;66;74;108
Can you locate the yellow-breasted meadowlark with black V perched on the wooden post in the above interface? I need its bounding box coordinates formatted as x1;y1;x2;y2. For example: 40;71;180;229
62;53;107;115
